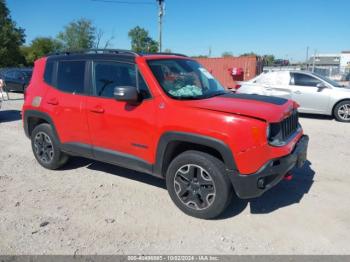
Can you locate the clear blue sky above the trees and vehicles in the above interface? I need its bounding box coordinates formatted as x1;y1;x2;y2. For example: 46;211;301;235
6;0;350;61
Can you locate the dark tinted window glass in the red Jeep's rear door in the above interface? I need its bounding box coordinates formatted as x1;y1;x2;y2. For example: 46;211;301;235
57;61;85;94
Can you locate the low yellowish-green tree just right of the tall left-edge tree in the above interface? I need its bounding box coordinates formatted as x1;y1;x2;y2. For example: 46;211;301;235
21;37;62;65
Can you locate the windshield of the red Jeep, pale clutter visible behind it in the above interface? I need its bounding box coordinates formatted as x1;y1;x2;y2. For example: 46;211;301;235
148;59;226;99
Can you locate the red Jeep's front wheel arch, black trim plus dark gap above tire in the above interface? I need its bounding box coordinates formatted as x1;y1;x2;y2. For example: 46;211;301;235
154;132;237;177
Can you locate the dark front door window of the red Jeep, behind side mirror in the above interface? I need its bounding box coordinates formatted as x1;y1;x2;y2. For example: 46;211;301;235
94;62;151;99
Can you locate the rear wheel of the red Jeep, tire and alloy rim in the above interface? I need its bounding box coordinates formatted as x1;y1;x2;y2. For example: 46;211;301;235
31;124;69;170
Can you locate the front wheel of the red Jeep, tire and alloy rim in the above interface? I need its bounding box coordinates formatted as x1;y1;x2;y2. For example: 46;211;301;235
166;151;233;219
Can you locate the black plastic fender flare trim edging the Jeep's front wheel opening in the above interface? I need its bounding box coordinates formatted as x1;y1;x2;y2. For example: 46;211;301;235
153;131;237;177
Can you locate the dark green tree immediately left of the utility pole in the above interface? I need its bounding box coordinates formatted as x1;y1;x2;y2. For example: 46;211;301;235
128;26;158;53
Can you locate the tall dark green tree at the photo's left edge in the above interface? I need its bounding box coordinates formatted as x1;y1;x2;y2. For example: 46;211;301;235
0;0;25;67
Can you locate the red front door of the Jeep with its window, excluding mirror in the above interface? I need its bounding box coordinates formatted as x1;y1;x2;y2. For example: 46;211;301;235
87;61;155;170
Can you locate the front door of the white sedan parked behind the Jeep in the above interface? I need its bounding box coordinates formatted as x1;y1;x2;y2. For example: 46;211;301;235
291;73;331;114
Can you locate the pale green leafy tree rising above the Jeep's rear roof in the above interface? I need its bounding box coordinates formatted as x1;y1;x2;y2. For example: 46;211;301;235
57;18;96;50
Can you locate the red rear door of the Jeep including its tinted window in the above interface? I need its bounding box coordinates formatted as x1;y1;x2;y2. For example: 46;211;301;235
44;60;91;155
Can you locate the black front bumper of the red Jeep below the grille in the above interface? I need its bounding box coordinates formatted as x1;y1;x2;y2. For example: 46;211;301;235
230;135;309;199
